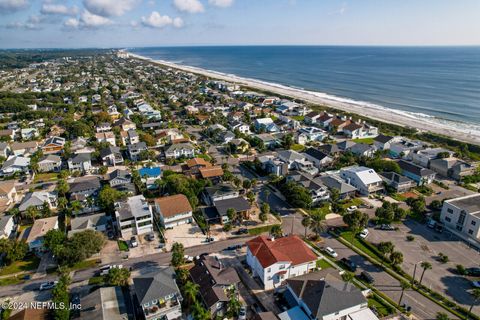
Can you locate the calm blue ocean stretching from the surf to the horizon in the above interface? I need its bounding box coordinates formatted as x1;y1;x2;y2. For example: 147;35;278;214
128;46;480;130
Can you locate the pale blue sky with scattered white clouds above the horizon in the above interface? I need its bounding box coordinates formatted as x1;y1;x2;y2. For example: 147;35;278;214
0;0;480;48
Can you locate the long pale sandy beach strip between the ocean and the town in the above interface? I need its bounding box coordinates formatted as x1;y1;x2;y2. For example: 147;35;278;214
127;51;480;145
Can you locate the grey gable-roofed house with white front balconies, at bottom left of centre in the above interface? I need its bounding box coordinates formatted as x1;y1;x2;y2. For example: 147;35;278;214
133;266;182;320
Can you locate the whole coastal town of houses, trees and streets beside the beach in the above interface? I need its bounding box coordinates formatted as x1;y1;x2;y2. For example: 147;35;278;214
0;50;480;320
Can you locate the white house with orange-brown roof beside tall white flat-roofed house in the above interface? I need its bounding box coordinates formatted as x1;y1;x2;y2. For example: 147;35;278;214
155;194;193;228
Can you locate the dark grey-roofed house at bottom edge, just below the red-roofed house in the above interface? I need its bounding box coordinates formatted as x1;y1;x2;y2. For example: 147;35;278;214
278;269;378;320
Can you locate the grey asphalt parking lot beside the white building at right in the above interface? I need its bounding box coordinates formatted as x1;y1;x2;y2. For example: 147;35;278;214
367;220;480;312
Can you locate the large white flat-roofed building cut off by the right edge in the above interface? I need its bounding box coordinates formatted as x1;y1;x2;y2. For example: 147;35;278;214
440;193;480;247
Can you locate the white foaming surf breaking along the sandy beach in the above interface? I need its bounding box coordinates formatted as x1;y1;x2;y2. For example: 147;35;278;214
128;53;480;137
